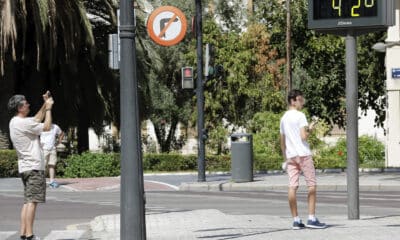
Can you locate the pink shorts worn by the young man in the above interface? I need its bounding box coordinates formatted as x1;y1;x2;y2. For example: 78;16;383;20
287;155;317;187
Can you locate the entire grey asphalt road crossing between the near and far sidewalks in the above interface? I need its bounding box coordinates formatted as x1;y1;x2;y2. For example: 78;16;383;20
0;187;400;236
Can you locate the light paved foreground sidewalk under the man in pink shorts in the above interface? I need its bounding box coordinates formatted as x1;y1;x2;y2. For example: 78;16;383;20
85;209;400;240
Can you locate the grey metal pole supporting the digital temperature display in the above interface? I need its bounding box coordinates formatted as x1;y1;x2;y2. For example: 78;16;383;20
346;30;360;219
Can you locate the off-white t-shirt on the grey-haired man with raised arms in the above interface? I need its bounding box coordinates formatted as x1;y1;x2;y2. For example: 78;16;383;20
9;116;45;173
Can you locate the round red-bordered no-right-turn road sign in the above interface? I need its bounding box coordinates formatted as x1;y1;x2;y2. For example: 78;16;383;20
147;6;187;46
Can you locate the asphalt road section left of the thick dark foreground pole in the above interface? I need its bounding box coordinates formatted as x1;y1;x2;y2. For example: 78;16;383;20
0;192;119;236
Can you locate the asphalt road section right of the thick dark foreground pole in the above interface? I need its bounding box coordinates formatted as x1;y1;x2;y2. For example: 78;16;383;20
146;191;400;218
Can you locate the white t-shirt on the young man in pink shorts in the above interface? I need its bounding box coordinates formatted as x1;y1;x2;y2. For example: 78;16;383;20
280;110;311;159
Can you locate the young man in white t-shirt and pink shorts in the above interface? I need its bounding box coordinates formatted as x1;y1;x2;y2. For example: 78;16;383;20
280;90;326;230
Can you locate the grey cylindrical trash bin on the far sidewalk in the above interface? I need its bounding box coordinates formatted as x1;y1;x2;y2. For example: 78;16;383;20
231;133;253;182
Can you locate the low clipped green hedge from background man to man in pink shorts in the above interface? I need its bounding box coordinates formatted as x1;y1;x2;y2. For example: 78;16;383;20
60;153;282;177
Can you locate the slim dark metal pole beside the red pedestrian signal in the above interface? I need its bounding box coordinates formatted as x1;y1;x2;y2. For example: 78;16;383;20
195;0;206;182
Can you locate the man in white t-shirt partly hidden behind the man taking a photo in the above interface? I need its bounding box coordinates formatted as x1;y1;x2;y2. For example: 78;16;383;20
40;124;64;188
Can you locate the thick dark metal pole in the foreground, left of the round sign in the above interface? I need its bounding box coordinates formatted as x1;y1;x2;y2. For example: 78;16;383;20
120;0;146;240
